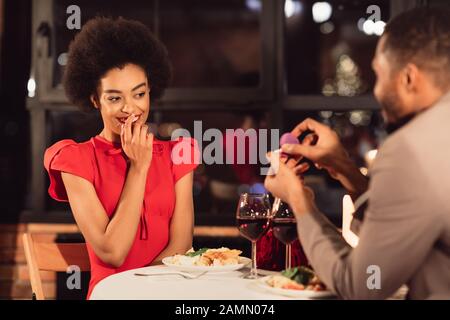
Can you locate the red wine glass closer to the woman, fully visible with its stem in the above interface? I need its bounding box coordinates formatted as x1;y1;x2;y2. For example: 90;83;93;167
236;193;270;279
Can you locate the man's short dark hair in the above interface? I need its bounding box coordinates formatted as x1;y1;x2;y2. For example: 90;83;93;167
384;7;450;88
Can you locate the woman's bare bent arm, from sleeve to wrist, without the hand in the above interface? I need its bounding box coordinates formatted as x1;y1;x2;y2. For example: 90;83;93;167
61;164;147;267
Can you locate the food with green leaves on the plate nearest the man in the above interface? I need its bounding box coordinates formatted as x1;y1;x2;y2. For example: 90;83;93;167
266;266;326;291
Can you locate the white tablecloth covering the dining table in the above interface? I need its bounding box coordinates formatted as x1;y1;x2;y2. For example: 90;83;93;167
90;266;302;300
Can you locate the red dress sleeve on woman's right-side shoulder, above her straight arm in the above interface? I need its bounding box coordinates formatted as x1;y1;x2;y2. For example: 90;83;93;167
170;137;200;182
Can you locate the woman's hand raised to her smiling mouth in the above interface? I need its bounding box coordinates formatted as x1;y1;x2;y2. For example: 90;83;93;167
120;115;153;172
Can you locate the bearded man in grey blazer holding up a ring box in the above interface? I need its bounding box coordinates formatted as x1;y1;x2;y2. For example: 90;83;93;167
265;8;450;299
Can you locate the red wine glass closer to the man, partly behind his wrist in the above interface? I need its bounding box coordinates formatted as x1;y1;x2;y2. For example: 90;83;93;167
272;198;298;269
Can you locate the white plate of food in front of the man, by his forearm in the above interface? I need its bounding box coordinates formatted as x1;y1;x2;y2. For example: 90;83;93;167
257;266;336;299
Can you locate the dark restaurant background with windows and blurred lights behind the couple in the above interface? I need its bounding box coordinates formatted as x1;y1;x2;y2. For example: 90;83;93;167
0;0;448;298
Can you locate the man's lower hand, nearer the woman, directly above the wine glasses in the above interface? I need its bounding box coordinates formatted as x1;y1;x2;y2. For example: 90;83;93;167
264;152;316;215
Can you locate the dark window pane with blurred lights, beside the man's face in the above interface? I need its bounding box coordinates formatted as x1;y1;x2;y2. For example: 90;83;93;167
285;0;389;96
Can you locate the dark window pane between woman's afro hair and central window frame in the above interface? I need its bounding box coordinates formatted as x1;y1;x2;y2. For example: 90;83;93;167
158;0;261;87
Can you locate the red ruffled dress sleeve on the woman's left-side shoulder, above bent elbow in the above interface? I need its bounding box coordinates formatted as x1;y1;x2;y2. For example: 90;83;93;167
44;139;94;201
